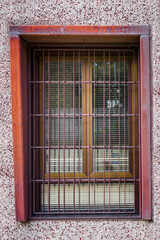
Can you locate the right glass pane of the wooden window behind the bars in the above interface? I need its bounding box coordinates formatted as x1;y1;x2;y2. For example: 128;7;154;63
92;61;129;172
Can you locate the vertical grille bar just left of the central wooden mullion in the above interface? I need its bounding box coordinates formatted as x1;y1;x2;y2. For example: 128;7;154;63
78;51;80;212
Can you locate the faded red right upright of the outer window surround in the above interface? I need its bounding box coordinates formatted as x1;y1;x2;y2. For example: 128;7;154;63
140;36;151;219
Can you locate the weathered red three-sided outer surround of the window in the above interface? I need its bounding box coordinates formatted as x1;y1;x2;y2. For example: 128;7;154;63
10;26;151;221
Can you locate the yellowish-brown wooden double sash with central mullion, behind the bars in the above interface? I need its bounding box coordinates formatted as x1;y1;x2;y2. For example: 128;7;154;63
39;53;138;179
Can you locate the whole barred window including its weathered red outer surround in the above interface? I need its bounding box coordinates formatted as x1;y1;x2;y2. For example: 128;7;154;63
11;26;151;221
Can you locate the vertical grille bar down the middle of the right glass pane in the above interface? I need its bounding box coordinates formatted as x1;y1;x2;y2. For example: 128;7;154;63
108;51;111;212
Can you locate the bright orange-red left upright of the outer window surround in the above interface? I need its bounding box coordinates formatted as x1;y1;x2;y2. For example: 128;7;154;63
10;37;27;221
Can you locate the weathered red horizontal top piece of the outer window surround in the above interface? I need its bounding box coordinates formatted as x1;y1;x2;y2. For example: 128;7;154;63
10;26;150;36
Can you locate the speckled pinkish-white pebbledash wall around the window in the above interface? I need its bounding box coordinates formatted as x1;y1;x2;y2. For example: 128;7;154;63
0;0;160;240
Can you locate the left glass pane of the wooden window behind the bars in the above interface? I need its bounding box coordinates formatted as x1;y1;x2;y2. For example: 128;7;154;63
45;59;83;177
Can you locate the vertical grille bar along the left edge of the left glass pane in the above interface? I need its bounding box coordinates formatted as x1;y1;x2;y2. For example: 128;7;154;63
48;51;51;212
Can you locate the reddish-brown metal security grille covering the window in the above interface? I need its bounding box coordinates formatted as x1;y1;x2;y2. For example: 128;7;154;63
29;47;140;218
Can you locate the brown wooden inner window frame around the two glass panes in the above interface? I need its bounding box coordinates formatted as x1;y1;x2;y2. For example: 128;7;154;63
37;57;138;179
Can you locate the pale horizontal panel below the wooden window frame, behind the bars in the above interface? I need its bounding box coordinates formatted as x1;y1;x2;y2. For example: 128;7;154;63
41;183;134;212
